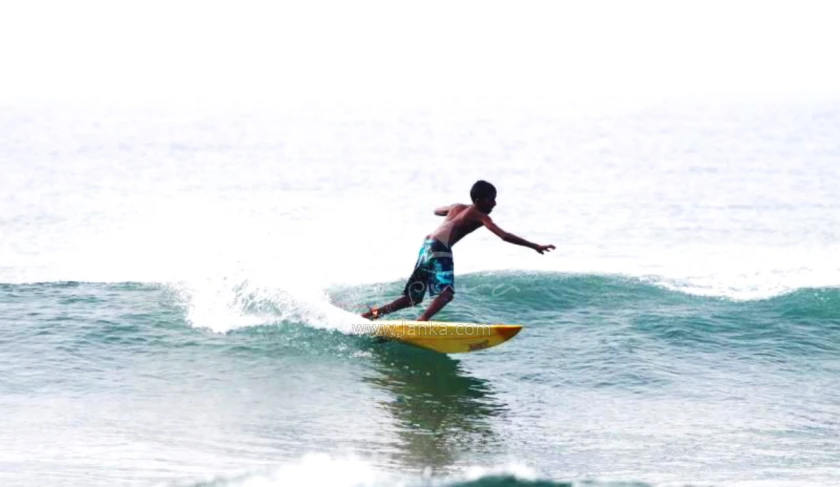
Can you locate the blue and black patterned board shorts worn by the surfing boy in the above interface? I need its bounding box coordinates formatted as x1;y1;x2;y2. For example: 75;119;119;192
403;238;455;304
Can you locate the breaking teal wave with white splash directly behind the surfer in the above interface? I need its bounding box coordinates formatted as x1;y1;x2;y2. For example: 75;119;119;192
0;271;840;342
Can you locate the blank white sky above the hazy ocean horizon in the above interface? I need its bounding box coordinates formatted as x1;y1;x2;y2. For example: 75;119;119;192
0;0;840;106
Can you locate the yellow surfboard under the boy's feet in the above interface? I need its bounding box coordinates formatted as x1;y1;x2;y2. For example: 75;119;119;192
365;320;522;353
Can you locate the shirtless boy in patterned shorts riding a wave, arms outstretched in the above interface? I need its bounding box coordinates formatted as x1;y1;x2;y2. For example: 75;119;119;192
362;180;555;321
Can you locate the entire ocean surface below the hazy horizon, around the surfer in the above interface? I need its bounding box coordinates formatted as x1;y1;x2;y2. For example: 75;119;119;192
0;93;840;487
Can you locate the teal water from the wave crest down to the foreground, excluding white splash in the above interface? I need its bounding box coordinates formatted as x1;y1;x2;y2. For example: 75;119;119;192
0;273;840;486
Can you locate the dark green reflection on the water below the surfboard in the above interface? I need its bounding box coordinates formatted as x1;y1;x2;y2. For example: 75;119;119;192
364;343;505;472
